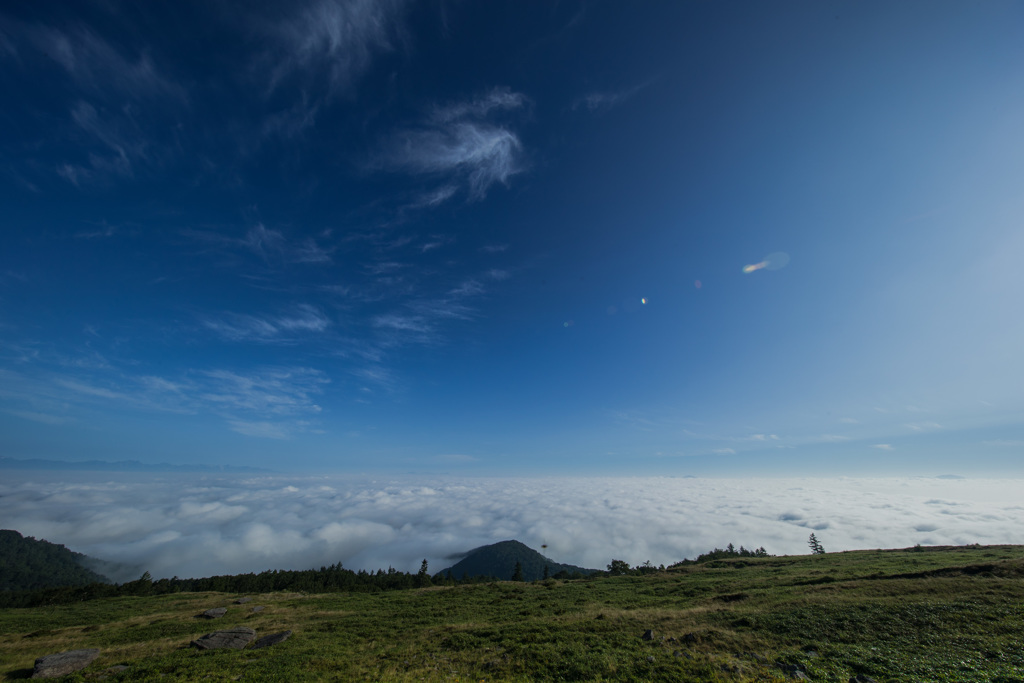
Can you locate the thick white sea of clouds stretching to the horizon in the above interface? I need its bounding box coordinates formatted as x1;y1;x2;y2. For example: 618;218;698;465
0;471;1024;581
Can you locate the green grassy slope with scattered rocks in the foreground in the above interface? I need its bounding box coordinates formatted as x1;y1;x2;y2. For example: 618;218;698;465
0;546;1024;683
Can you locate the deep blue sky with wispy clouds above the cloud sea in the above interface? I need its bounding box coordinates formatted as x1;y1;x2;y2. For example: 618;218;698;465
0;0;1024;476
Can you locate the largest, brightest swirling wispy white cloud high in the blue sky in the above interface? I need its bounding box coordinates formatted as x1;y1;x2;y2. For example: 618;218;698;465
370;89;527;206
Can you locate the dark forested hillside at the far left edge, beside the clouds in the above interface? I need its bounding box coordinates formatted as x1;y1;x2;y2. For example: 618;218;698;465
0;529;110;591
